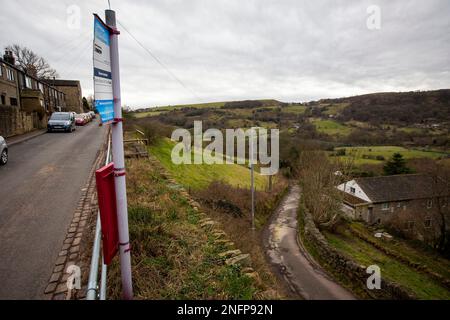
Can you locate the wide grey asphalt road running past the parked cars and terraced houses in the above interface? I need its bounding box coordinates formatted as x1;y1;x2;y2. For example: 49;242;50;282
0;122;106;300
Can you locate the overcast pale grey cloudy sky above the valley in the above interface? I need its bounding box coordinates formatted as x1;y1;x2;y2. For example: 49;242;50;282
0;0;450;108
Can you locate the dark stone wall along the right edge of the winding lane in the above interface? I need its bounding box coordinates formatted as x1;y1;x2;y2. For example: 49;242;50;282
300;207;416;300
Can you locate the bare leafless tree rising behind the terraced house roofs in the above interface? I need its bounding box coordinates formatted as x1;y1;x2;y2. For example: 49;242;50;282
6;44;58;79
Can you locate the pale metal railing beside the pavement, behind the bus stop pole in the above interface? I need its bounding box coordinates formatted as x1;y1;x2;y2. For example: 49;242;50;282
86;135;112;300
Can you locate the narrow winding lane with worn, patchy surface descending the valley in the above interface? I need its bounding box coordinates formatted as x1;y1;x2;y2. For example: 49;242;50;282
264;186;355;300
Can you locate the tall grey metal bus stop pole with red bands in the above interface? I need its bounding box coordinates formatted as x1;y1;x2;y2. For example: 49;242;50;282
105;10;133;300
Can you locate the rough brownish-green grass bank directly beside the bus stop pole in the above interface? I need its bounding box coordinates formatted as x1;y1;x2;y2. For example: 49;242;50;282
108;160;258;300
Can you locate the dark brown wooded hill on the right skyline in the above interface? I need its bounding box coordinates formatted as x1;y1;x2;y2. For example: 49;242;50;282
313;89;450;125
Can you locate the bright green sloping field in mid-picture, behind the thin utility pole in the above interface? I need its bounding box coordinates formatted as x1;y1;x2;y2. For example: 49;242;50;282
150;139;268;191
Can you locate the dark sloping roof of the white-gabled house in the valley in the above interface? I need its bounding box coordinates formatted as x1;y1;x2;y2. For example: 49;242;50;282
355;174;449;203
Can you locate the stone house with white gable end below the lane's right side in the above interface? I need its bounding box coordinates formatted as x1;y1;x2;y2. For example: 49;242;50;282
338;174;450;240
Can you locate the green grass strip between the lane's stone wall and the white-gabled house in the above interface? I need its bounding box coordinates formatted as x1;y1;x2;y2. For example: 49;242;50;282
325;224;450;300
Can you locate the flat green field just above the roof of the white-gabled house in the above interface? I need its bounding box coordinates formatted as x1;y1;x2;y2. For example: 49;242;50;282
336;146;447;165
